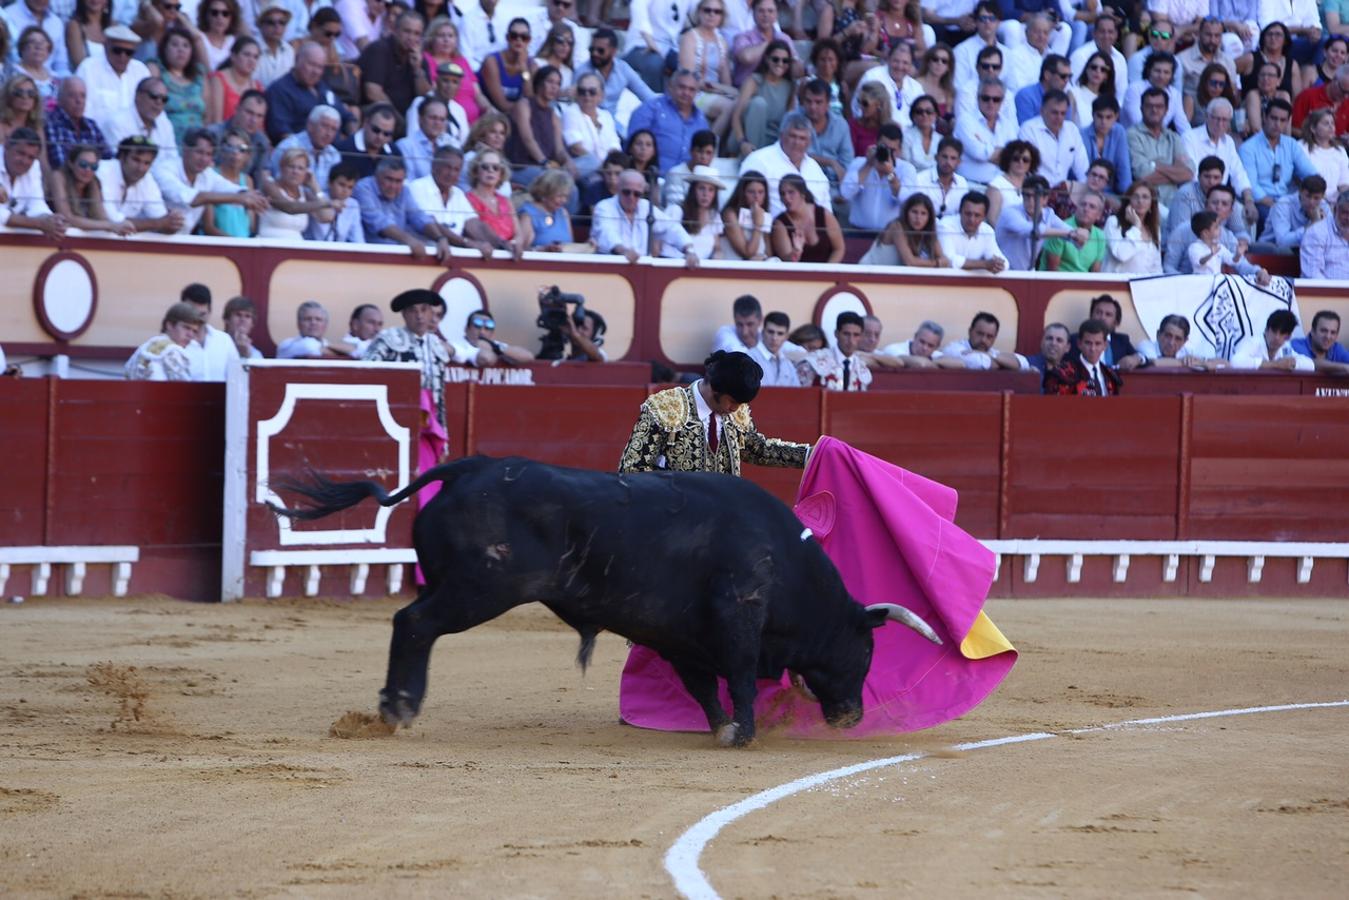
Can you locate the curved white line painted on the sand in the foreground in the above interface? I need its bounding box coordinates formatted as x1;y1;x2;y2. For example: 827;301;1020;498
665;700;1349;900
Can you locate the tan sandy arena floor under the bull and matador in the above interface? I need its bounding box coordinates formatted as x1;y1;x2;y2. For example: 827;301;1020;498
0;599;1349;899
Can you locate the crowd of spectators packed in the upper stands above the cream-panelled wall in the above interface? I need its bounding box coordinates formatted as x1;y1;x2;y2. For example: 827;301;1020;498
0;0;1349;278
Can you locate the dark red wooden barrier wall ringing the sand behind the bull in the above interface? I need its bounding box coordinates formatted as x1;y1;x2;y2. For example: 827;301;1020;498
0;379;1349;599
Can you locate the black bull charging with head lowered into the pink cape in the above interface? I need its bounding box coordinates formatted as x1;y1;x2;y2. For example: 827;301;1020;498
274;456;940;745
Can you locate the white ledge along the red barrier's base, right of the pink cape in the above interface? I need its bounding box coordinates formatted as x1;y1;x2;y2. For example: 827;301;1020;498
983;538;1349;584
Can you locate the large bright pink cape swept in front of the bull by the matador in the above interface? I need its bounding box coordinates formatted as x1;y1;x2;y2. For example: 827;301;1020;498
619;437;1016;739
